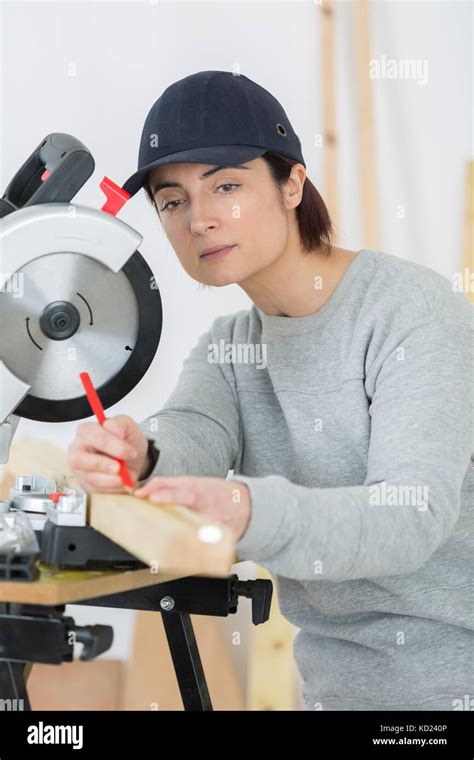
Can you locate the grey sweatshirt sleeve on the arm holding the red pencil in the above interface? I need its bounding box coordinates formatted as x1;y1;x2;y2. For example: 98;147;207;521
140;324;241;484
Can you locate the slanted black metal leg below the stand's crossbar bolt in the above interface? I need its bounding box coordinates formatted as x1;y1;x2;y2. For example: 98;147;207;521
161;612;212;710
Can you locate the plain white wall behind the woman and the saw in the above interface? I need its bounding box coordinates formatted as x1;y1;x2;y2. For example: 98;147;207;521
0;0;472;656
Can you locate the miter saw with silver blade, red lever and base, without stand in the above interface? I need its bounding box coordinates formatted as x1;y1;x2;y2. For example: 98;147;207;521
0;133;162;580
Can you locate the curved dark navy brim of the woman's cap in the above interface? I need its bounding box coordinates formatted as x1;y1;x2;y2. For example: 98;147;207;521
122;145;267;195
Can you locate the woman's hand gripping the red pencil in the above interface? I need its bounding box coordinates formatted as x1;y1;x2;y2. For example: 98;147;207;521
68;415;148;493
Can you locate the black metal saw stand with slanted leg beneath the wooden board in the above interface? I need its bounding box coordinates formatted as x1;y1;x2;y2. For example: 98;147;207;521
0;574;273;711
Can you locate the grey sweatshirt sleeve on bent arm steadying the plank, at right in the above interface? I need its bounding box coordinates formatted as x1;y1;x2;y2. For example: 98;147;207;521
232;315;474;581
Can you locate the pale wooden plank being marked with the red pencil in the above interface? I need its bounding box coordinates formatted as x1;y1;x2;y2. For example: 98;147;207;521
89;493;235;576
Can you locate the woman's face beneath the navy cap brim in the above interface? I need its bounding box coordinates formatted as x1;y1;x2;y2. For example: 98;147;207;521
148;157;304;286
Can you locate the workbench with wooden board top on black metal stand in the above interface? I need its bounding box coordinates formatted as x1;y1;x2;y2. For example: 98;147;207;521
0;564;272;710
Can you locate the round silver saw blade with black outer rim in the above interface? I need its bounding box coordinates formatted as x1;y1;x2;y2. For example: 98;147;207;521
0;251;162;422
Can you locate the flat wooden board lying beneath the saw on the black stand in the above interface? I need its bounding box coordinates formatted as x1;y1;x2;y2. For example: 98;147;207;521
0;563;187;605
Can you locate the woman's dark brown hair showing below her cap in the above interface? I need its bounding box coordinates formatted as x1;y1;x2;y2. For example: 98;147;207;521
144;151;334;256
